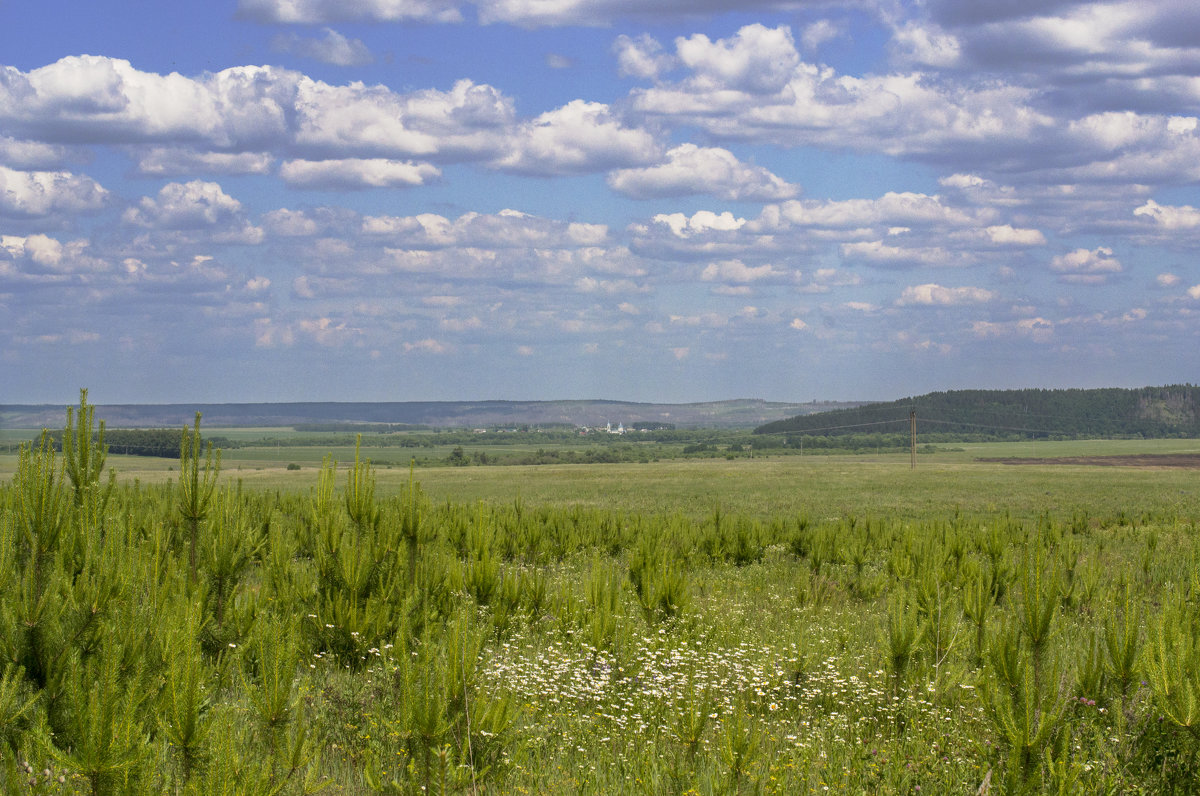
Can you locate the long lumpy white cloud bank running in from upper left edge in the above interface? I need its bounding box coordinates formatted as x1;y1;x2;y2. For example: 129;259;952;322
0;55;520;164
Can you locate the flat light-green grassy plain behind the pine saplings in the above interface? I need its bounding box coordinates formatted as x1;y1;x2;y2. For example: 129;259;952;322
0;429;1200;520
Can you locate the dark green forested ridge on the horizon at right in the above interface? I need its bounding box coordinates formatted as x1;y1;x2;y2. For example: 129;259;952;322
755;384;1200;438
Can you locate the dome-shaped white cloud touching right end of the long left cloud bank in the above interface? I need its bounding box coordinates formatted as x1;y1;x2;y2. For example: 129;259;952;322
493;100;660;175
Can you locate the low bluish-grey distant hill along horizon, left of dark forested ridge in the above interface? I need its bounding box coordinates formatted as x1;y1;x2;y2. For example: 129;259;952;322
0;399;858;429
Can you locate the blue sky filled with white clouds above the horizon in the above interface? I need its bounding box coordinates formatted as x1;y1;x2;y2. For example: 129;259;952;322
0;0;1200;405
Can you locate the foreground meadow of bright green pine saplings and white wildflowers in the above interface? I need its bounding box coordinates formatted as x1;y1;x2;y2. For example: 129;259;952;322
0;393;1200;794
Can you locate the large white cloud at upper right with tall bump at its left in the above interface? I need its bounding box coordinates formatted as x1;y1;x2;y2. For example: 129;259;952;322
631;25;1054;161
